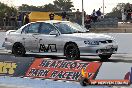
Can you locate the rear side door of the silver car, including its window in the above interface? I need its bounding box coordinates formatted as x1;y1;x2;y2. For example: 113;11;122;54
22;23;40;52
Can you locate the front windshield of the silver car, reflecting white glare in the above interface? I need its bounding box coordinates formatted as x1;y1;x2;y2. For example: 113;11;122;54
54;22;87;34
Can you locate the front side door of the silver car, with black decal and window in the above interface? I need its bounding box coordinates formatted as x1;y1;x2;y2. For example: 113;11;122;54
38;23;60;53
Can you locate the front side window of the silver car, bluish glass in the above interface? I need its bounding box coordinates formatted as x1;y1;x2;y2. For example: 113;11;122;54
40;23;56;34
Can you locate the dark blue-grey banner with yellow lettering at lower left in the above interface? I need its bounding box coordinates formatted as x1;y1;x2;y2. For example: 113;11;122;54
0;55;34;77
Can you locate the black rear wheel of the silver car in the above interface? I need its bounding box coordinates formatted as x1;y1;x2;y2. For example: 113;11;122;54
12;43;26;56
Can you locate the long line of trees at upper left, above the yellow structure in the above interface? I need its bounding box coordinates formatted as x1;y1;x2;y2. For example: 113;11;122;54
0;0;74;18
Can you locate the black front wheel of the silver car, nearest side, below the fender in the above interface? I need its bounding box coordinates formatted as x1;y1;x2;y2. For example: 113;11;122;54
64;43;80;60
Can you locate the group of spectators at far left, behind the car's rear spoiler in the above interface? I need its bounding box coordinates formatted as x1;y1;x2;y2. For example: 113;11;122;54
3;12;30;28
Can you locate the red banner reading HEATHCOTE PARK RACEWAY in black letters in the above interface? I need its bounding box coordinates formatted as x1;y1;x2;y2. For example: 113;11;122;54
26;58;101;81
